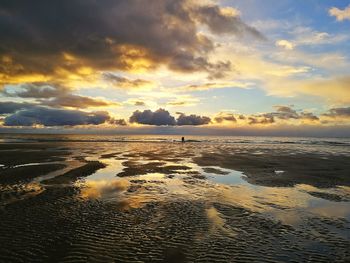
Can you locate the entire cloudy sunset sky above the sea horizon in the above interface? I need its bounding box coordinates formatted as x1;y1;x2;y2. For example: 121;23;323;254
0;0;350;137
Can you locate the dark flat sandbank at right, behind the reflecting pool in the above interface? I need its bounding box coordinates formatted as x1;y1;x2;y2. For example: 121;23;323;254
194;153;350;188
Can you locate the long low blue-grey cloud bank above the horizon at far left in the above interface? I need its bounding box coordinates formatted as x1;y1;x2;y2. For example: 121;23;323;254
3;107;111;126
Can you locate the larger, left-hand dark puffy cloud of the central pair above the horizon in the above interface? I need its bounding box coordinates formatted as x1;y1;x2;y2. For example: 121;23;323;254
129;109;176;126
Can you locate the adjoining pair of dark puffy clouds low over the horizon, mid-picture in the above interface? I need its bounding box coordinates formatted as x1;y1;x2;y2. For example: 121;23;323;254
129;109;210;126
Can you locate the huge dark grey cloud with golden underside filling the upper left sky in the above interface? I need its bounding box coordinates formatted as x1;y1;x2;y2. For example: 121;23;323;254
0;0;263;83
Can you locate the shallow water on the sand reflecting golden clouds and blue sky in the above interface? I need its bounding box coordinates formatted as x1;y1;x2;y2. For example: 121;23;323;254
76;148;350;231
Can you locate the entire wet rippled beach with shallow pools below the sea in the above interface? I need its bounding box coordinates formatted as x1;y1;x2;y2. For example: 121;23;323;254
0;142;350;262
